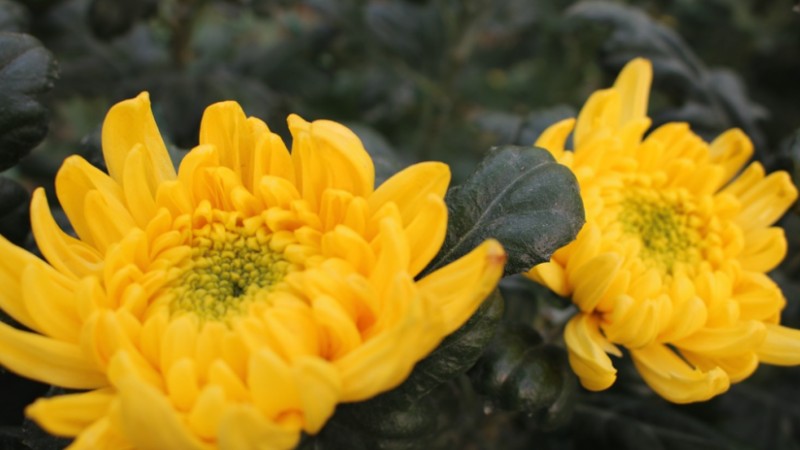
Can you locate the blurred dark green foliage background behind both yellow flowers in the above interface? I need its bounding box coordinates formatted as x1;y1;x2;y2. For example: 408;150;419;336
0;0;800;450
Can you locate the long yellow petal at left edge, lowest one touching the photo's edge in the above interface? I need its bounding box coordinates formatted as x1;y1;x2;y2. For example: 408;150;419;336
0;323;108;389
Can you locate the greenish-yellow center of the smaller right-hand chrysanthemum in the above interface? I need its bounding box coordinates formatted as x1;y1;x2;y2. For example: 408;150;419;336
617;189;699;274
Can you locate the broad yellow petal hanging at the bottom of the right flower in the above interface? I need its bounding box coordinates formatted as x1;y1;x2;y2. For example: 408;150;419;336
631;344;730;403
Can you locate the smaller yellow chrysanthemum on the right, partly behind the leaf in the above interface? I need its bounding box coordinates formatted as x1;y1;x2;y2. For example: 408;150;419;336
529;59;800;403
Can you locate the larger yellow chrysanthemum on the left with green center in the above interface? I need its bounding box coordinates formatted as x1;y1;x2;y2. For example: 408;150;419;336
0;94;505;450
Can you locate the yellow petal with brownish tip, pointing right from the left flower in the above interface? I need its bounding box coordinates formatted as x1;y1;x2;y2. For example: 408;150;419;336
417;239;506;334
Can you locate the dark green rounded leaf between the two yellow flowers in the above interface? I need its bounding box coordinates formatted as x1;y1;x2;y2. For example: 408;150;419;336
430;146;584;274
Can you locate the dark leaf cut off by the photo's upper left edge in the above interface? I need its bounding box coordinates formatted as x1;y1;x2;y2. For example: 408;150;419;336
0;32;56;171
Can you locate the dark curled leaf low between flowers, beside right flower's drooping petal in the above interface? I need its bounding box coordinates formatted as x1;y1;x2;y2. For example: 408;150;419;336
471;326;577;427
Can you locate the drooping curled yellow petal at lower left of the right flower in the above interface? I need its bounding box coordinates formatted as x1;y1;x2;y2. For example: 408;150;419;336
564;313;619;391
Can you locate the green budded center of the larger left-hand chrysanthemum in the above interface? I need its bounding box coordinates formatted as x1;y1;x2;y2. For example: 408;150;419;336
170;216;296;321
